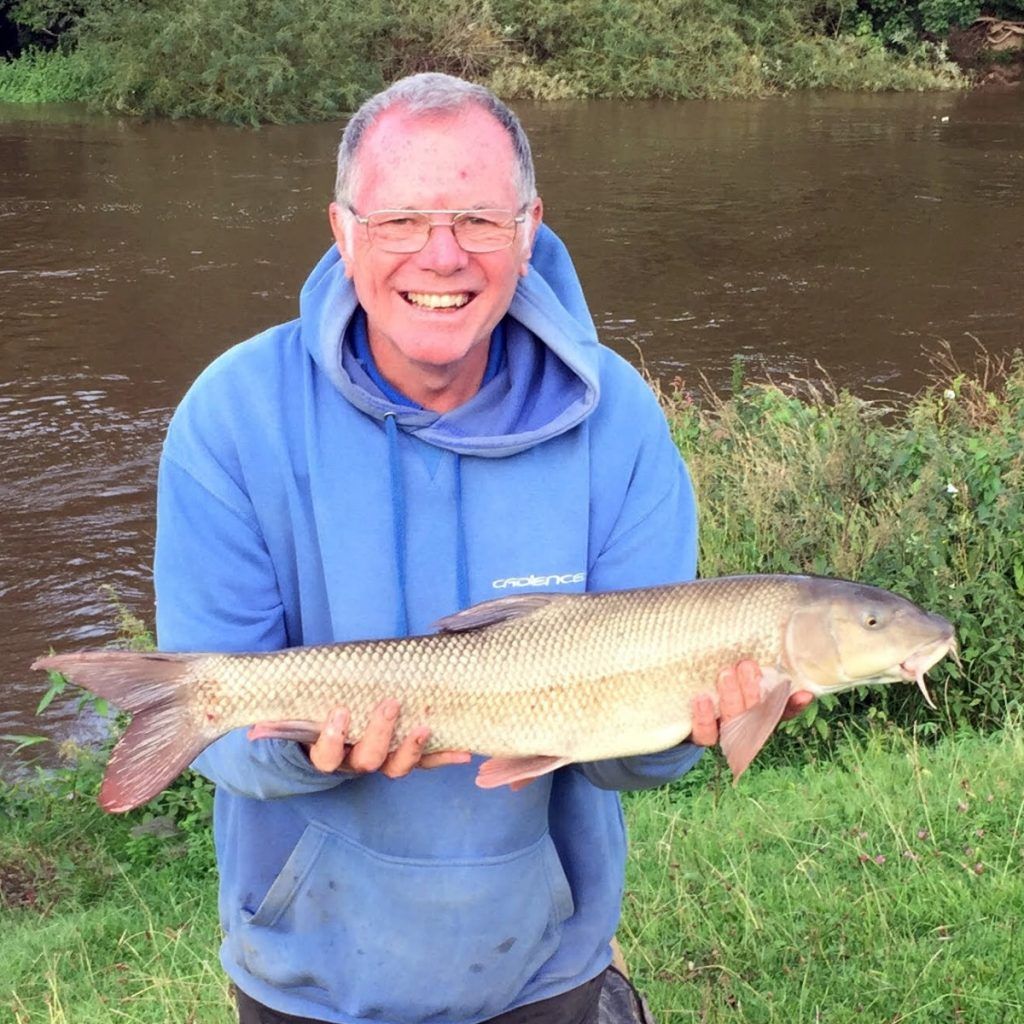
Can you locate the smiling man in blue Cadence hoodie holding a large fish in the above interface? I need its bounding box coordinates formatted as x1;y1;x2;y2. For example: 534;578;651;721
156;75;806;1024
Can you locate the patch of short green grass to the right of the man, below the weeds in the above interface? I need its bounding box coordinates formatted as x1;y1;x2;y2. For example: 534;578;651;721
620;727;1024;1024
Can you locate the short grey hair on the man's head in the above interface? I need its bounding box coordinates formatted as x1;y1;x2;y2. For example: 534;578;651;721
334;72;537;205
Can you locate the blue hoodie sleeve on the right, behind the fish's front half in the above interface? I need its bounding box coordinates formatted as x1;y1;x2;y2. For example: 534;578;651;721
580;368;703;790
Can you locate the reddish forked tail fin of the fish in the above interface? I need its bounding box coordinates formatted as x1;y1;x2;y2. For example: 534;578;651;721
32;650;209;812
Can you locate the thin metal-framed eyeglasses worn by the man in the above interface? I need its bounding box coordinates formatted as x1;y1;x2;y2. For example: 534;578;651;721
348;207;526;253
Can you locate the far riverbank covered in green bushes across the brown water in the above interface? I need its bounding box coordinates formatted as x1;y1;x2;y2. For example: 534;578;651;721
0;0;974;124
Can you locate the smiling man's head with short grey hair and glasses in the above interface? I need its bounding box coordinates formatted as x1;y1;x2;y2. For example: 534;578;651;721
331;75;542;408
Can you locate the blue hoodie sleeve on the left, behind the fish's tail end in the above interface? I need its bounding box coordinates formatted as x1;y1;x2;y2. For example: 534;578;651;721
154;415;346;799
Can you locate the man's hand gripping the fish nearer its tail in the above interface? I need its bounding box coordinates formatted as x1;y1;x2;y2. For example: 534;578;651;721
306;700;470;778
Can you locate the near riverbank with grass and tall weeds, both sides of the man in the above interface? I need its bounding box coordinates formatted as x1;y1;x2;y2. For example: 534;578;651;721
0;353;1024;1024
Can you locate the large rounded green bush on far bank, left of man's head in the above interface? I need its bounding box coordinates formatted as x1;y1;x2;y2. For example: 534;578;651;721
68;0;388;124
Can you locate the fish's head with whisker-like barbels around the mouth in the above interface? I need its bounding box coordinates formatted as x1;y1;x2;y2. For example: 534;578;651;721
785;580;956;708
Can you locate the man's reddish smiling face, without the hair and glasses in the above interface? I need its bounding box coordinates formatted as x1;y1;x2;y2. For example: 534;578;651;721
331;106;542;393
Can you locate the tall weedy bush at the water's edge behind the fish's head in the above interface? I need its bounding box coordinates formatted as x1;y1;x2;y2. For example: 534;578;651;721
669;353;1024;733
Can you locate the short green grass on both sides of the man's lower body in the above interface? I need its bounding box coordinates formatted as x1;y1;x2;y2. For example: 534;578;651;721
0;727;1024;1024
